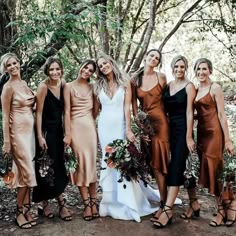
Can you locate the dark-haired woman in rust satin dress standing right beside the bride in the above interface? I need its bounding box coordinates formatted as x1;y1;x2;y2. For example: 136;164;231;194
132;49;169;221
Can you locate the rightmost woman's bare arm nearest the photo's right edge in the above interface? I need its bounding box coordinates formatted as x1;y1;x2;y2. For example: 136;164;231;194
212;83;234;155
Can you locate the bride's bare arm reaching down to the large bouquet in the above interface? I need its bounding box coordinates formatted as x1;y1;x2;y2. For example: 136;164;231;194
124;82;135;142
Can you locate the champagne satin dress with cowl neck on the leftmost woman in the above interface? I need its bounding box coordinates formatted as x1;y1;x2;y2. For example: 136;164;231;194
3;84;37;188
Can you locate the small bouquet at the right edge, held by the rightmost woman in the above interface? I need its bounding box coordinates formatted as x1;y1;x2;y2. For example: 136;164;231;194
219;152;236;183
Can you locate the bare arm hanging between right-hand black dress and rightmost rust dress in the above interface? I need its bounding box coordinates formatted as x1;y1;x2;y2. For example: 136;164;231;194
186;83;196;153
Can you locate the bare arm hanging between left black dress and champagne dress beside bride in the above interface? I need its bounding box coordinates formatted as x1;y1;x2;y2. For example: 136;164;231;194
63;84;71;146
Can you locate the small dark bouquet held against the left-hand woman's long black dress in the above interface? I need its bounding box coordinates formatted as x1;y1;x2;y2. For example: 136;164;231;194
37;149;55;186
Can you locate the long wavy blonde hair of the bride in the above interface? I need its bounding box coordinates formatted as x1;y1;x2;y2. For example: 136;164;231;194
94;53;129;96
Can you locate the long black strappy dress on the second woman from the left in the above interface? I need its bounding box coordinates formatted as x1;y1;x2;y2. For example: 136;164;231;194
32;86;69;202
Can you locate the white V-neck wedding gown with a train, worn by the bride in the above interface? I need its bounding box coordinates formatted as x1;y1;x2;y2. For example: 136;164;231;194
98;87;160;222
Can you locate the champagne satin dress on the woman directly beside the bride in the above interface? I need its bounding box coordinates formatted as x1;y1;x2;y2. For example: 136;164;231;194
70;83;97;187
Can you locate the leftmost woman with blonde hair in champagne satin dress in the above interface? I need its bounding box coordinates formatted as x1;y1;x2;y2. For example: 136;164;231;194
1;53;36;229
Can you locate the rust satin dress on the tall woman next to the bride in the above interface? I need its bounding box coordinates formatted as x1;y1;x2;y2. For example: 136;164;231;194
136;83;170;175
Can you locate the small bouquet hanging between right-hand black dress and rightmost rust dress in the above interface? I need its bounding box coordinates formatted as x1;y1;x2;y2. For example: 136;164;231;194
184;155;200;188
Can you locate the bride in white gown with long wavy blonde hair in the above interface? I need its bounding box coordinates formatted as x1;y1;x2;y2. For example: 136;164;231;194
94;55;160;222
